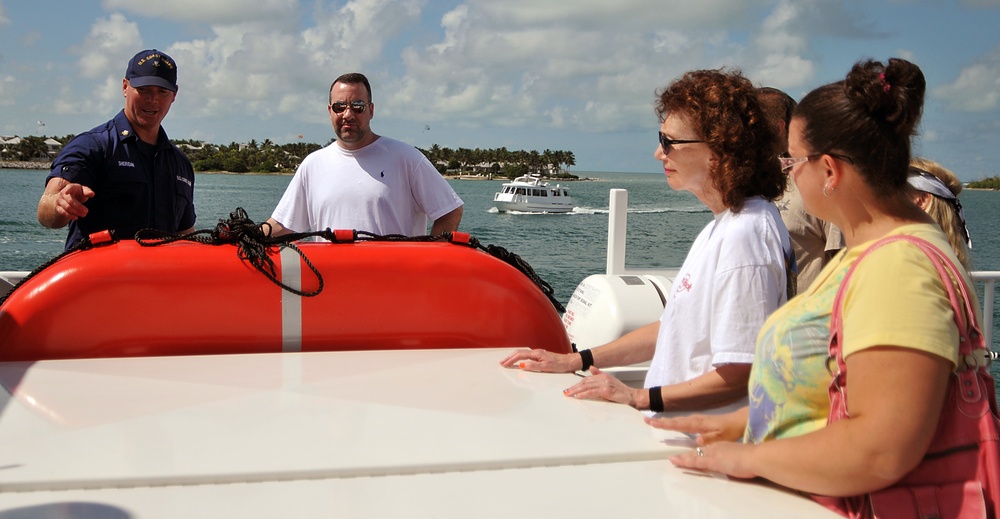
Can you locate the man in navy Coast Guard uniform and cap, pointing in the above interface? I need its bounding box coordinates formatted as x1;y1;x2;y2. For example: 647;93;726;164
38;49;195;249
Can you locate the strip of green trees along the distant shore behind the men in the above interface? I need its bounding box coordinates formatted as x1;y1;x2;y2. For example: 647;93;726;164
0;135;577;179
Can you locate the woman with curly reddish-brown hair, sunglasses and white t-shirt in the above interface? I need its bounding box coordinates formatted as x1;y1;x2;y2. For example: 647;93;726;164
501;70;792;418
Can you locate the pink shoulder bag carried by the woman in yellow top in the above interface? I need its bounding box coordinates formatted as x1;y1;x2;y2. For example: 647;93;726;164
813;235;1000;519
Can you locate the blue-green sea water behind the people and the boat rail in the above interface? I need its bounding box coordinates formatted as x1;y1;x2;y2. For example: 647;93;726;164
0;170;1000;392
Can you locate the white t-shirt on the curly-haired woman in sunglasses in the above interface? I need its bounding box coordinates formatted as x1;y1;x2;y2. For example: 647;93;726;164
645;198;791;408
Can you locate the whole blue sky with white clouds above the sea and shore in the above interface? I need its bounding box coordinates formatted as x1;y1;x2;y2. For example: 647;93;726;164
0;0;1000;180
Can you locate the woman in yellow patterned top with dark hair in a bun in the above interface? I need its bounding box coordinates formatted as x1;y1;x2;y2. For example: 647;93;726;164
649;55;979;504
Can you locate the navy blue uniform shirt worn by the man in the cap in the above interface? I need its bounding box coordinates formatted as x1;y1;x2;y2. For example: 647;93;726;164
45;110;195;249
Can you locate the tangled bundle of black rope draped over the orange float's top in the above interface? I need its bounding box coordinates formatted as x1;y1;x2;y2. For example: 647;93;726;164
135;207;324;297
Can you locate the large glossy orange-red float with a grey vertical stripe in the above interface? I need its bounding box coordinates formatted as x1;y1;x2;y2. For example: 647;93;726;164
0;241;571;361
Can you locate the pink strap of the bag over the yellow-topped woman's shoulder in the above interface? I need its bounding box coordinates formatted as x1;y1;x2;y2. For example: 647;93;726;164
827;234;992;416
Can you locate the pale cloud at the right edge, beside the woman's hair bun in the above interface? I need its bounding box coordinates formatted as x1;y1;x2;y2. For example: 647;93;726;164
931;46;1000;112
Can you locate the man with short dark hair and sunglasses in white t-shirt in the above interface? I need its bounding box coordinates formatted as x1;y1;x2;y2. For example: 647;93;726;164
267;73;463;236
